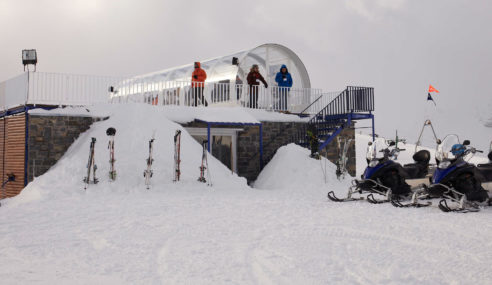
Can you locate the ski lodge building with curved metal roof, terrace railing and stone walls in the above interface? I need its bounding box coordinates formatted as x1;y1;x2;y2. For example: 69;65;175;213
0;44;374;199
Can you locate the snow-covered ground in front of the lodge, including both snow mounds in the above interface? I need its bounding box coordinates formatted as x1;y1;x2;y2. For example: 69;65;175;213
0;105;492;284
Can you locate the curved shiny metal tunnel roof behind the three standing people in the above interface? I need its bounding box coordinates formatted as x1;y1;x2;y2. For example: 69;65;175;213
134;43;311;88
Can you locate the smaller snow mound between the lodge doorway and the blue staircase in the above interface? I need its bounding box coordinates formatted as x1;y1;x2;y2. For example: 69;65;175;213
254;144;350;196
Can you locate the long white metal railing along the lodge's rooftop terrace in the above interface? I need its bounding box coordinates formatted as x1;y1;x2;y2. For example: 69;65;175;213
0;72;330;114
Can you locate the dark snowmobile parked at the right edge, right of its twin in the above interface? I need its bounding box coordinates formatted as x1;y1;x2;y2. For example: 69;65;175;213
424;135;492;213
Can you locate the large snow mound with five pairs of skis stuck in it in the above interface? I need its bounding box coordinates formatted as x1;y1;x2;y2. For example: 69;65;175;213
2;104;248;205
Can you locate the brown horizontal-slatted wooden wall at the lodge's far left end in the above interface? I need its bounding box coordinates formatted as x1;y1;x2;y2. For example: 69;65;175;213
0;113;26;199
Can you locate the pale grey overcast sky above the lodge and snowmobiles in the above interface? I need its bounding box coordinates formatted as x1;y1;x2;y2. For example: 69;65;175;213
0;0;492;147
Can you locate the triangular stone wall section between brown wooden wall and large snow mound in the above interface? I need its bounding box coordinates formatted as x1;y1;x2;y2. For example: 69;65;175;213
26;115;101;182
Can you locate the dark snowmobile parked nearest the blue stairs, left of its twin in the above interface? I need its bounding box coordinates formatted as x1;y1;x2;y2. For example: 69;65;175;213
328;139;430;206
